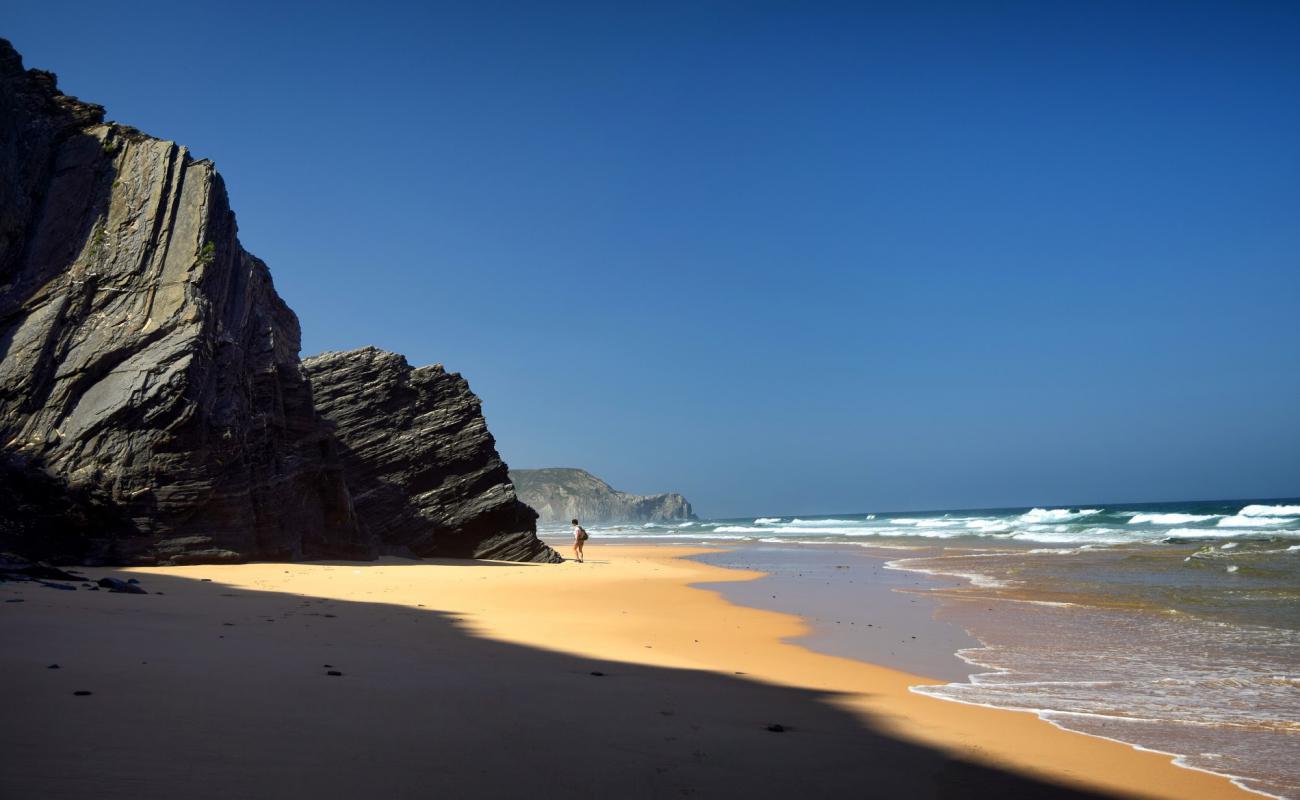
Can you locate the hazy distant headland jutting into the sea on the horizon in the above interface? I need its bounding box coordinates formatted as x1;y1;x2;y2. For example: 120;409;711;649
510;467;696;523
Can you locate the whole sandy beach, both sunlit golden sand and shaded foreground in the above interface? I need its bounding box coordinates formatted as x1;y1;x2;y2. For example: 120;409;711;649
0;546;1249;799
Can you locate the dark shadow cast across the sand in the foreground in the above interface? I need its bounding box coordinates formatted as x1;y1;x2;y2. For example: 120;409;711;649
0;563;1123;800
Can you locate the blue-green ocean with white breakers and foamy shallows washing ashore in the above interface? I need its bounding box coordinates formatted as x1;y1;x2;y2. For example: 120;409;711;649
542;498;1300;799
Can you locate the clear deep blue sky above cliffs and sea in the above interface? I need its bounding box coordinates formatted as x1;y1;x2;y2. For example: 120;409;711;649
0;0;1300;516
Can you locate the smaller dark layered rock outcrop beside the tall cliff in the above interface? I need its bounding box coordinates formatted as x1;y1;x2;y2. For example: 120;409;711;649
303;347;560;562
